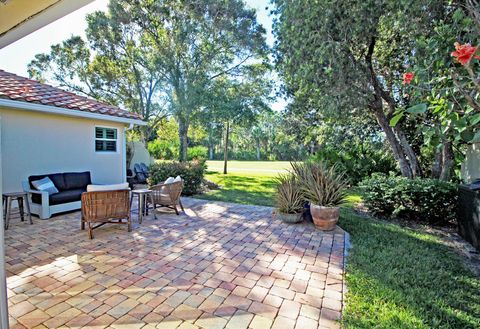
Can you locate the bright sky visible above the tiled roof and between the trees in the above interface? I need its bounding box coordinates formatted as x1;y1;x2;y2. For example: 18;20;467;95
0;0;285;110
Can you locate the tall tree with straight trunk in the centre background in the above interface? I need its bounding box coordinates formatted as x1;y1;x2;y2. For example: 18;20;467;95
114;0;267;161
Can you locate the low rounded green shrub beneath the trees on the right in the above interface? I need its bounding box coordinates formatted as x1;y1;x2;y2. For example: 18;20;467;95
360;174;457;225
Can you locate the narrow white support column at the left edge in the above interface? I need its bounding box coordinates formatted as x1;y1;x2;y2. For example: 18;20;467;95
0;115;9;328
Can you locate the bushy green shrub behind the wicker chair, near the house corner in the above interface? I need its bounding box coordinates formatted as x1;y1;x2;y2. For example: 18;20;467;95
148;161;206;195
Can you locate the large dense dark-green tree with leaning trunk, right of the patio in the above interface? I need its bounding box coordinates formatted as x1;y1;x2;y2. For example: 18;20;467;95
272;0;447;178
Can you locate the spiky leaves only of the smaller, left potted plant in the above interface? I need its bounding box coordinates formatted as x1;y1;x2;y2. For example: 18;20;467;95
275;174;305;214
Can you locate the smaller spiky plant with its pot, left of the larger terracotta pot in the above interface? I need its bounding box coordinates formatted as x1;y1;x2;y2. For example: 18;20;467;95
276;174;304;223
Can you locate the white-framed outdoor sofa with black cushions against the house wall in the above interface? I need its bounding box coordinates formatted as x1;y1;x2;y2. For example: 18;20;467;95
22;171;92;219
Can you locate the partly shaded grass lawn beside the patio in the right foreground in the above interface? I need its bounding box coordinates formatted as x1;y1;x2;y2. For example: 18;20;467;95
339;209;480;328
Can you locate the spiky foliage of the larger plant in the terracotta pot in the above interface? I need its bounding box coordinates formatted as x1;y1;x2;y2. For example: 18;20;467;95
292;162;347;207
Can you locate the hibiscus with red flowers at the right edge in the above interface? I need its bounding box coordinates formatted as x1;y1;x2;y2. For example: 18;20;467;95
392;0;480;180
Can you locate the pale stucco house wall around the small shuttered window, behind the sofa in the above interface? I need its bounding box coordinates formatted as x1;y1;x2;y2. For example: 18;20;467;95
0;108;126;193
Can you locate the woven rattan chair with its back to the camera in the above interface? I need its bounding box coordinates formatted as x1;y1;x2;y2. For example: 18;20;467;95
81;190;132;239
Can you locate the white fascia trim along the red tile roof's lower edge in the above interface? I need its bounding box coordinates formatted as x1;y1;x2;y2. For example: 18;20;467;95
0;99;147;126
